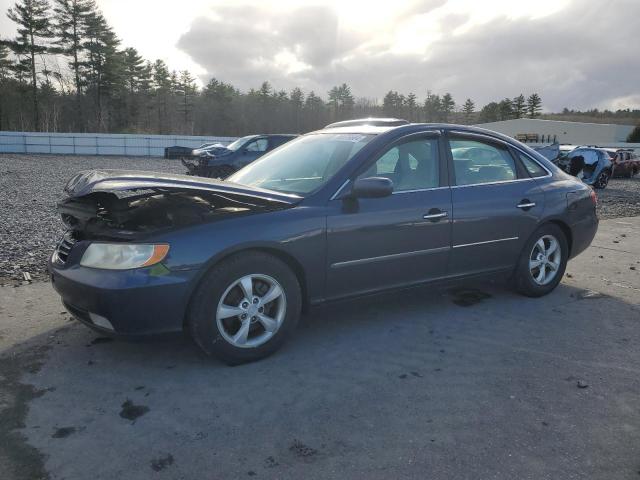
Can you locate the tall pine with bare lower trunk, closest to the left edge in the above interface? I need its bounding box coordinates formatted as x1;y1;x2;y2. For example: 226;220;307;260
7;0;53;130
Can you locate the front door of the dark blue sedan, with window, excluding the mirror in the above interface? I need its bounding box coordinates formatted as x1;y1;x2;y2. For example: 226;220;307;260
326;134;451;298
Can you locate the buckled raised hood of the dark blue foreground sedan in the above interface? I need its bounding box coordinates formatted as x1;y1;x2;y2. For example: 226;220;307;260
64;170;302;205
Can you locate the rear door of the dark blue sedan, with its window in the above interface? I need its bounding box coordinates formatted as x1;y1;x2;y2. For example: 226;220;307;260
447;133;548;275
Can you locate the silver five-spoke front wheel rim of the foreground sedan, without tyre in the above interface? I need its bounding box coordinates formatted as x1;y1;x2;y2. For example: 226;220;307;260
216;273;287;348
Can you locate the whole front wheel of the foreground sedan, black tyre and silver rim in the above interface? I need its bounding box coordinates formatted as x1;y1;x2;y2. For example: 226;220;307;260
188;252;302;365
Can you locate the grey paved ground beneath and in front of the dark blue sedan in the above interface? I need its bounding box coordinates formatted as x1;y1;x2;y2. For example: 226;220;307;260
0;217;640;480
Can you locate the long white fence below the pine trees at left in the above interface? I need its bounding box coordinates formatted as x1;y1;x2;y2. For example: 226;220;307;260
0;132;235;157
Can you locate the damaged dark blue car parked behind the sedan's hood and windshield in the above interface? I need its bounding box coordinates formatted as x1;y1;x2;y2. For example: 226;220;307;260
182;134;296;179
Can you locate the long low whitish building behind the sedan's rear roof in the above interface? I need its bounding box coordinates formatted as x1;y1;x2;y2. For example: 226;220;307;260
476;118;634;147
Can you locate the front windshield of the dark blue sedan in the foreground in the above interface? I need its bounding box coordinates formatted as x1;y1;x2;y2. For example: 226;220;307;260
227;133;374;195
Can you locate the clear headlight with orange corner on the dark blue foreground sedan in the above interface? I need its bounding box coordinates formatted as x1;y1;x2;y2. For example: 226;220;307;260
80;243;169;270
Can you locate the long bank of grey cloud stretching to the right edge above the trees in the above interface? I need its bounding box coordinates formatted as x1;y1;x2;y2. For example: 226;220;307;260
178;0;640;110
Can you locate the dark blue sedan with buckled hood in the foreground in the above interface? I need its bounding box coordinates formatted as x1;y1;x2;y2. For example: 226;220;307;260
50;124;598;364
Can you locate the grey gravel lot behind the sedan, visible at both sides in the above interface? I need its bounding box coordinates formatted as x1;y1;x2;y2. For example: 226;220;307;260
0;154;640;285
